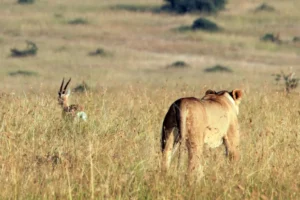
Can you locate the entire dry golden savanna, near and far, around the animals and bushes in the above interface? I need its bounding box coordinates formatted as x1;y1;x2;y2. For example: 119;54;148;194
0;0;300;200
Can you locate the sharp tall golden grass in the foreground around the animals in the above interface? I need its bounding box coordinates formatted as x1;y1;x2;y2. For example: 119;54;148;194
0;87;300;199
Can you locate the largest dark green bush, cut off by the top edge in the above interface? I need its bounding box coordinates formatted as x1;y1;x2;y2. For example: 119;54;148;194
165;0;226;13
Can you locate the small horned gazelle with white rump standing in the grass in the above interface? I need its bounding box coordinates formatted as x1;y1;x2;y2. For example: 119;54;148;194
57;78;87;121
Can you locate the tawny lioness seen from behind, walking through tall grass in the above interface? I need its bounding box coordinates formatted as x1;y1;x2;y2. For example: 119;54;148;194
161;89;242;176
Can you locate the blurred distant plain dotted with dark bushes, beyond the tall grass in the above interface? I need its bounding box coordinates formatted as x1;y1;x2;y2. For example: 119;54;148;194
0;0;300;93
